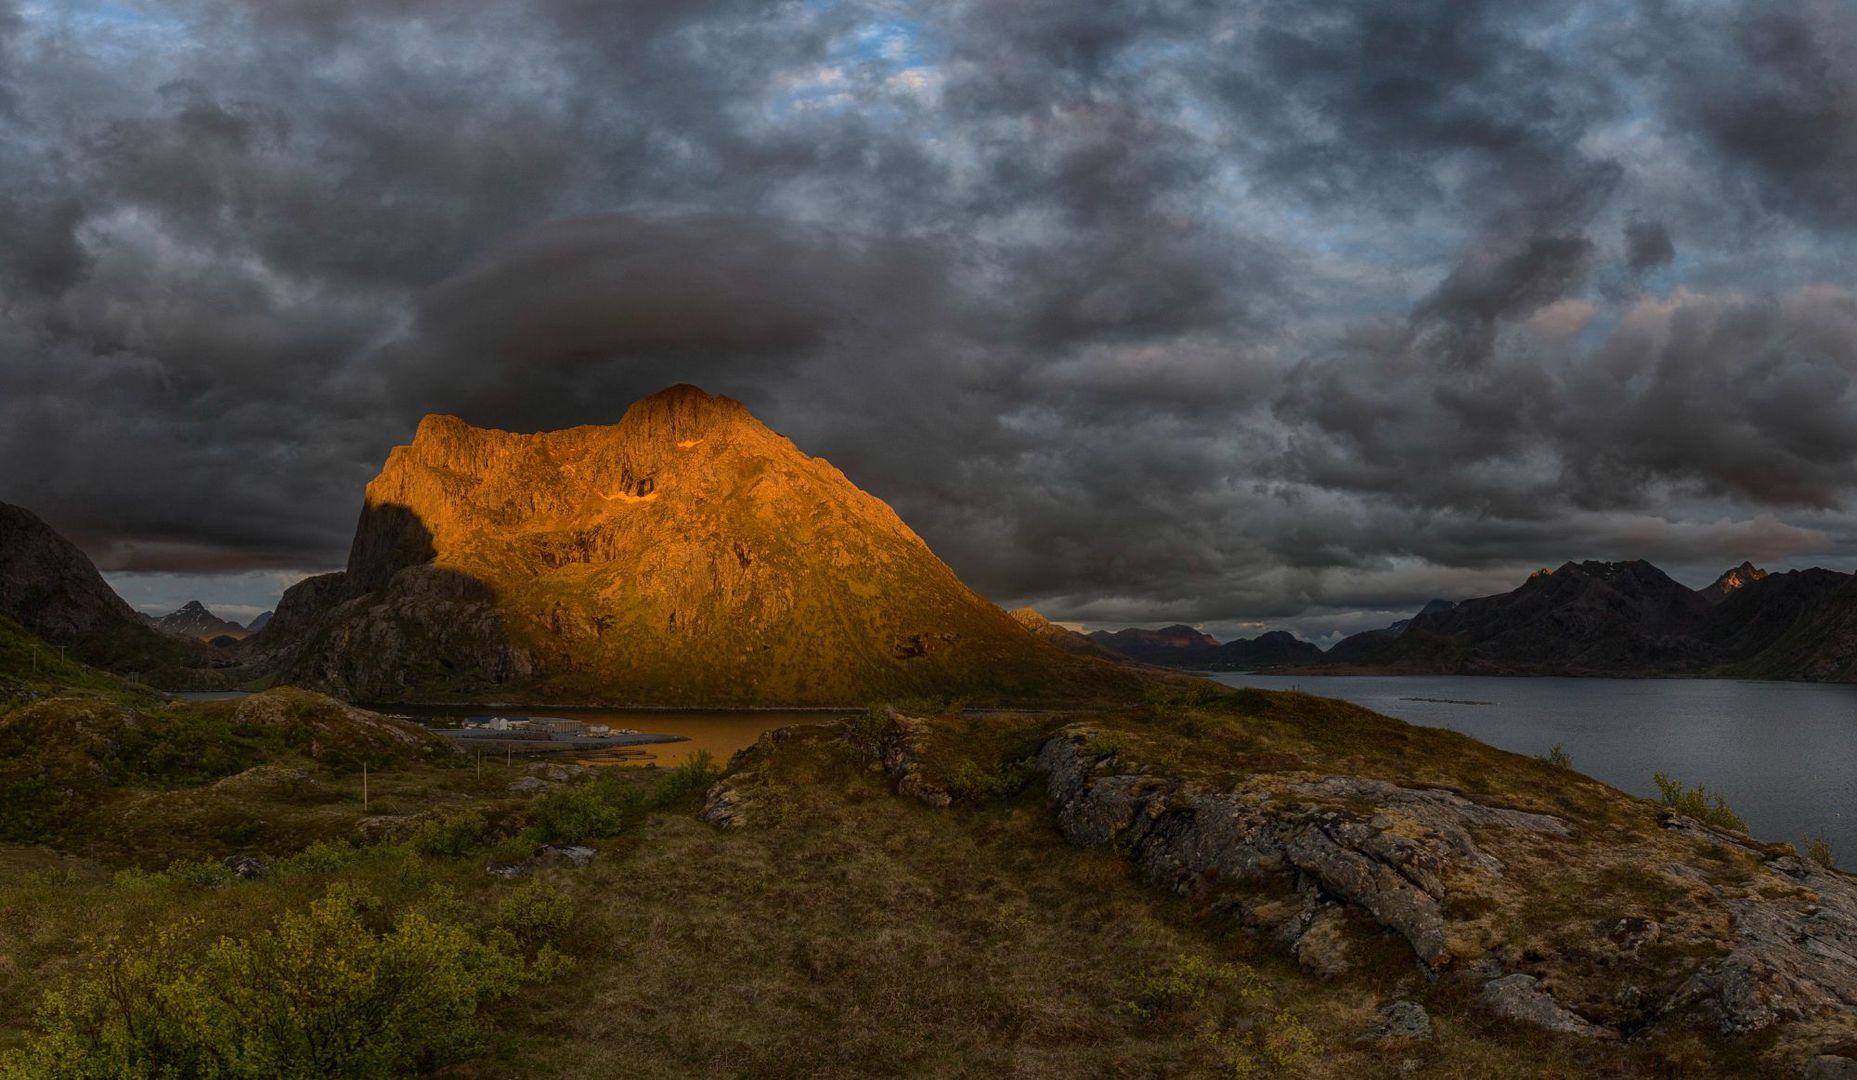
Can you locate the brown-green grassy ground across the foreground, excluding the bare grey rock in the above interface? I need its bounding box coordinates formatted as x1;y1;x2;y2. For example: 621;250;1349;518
0;642;1834;1080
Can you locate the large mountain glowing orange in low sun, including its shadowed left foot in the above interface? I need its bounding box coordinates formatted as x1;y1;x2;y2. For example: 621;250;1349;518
272;386;1138;705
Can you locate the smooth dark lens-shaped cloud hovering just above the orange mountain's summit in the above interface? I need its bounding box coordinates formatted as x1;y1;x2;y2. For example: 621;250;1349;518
376;213;947;427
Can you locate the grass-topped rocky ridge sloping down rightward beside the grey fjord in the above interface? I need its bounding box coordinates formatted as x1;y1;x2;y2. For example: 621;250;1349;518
706;692;1857;1076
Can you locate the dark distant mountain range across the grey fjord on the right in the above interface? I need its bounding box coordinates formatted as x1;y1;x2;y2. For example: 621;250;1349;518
1090;560;1857;681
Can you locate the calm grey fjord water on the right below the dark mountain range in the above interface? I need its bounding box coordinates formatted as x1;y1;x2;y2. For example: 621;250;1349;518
1211;672;1857;867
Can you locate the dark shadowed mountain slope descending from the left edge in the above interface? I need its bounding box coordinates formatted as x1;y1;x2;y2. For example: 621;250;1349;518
0;503;227;690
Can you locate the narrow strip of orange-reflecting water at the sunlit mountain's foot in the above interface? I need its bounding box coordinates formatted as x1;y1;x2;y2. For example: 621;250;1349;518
383;705;851;766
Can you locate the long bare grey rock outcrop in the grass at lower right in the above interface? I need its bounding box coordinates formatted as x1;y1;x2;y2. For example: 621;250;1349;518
1036;724;1857;1068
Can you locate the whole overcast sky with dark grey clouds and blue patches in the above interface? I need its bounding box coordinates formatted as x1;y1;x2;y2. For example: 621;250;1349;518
0;0;1857;642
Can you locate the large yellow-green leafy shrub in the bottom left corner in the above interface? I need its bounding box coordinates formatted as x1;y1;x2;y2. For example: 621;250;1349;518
0;885;544;1080
